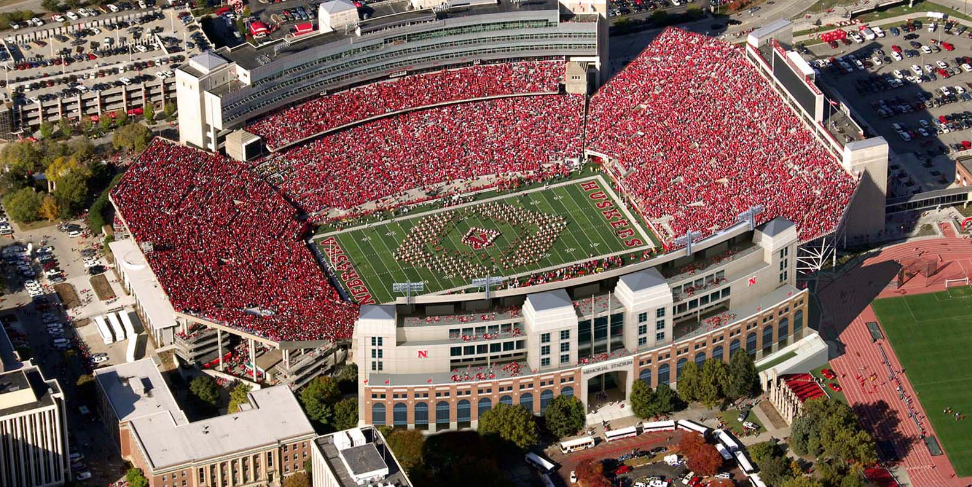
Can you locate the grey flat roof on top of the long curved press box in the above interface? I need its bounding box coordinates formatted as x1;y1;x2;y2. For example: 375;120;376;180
216;0;559;70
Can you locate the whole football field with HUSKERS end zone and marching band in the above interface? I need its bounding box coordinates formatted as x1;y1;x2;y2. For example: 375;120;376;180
314;176;654;304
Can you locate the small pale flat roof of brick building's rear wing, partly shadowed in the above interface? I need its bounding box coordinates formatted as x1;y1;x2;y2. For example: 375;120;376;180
95;358;189;425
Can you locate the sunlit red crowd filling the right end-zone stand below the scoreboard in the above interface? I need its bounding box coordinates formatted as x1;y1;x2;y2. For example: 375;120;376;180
587;28;856;240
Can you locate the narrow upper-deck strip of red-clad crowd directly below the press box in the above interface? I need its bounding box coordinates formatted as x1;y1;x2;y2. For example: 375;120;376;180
248;61;564;149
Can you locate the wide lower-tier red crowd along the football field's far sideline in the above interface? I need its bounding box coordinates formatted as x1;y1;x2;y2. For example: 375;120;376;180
255;95;584;216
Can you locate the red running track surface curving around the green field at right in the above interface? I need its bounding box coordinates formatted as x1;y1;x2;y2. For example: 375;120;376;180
819;237;972;487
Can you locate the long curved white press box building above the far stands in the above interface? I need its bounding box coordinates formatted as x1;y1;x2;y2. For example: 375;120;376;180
176;0;608;150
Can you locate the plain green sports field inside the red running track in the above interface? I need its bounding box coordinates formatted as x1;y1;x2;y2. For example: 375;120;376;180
872;286;972;477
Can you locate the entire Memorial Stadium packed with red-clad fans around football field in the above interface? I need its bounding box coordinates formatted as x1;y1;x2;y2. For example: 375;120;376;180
111;6;887;431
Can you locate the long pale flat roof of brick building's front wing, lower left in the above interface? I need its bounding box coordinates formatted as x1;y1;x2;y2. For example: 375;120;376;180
131;386;314;469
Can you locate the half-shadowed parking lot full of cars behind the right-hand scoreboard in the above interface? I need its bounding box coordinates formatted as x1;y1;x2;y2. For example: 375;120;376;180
805;19;972;196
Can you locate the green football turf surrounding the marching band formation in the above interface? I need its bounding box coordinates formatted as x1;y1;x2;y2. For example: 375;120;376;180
315;176;654;303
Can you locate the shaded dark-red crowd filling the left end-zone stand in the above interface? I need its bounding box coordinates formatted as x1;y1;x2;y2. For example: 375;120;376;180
111;139;358;340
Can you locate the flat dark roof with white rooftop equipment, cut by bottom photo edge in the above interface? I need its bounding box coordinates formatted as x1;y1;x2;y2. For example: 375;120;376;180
316;427;412;487
